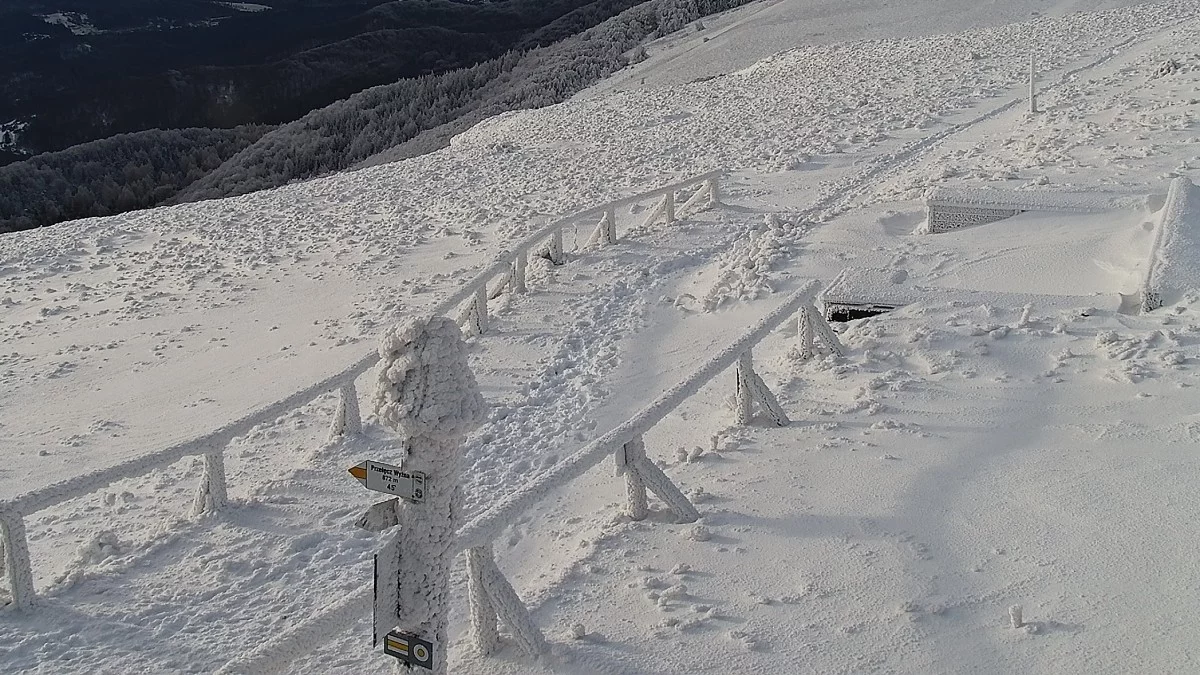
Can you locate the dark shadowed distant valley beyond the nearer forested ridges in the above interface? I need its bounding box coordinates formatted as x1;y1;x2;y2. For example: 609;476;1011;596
0;0;614;155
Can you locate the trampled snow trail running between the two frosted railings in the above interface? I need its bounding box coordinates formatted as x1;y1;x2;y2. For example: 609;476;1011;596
6;186;796;673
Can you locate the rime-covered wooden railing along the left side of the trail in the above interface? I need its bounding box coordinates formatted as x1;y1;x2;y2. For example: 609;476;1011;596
0;171;721;609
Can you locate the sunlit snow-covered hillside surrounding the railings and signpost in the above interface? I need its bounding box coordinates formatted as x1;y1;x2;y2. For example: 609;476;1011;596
0;0;1200;674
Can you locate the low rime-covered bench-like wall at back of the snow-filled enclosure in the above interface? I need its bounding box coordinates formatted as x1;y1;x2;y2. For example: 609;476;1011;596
918;186;1120;234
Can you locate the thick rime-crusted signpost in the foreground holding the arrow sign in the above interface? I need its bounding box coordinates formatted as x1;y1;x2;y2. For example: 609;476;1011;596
373;317;484;675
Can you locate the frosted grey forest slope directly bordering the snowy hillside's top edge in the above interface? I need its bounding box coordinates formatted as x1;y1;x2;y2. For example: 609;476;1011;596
181;0;752;202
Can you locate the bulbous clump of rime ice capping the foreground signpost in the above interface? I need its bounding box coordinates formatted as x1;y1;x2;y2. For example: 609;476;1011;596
373;317;484;440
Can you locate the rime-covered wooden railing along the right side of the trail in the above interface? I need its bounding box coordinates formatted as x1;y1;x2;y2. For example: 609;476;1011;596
218;276;842;674
